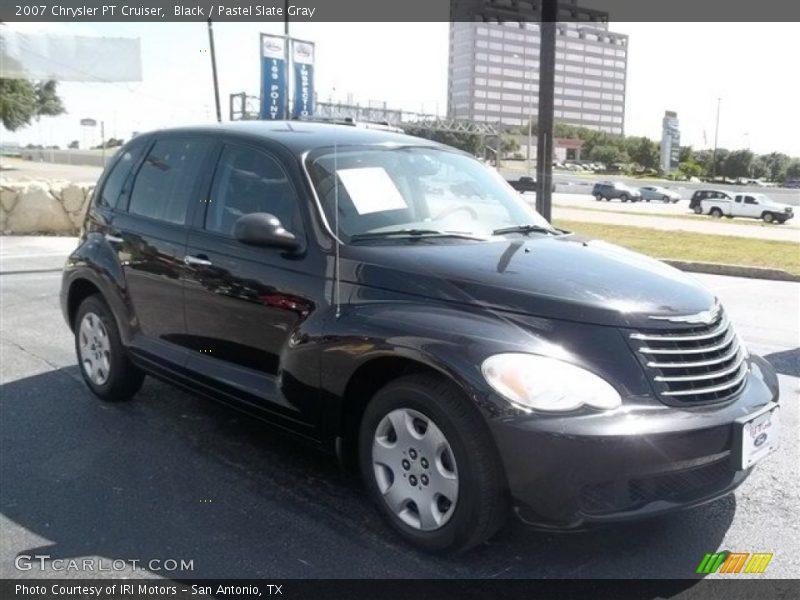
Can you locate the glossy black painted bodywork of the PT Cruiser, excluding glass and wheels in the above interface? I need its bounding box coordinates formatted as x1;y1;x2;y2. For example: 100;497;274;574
61;122;778;527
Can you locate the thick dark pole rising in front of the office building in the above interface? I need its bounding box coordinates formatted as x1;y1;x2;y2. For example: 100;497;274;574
536;0;558;221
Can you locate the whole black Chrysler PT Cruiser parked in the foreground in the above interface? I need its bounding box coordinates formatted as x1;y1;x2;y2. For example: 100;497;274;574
62;122;778;550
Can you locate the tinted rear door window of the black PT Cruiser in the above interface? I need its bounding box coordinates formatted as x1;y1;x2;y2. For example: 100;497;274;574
128;138;212;225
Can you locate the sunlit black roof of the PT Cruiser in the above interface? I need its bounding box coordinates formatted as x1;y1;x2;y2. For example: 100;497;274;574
142;121;444;155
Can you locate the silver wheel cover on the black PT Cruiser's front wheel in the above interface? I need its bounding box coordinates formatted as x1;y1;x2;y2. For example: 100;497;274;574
372;408;459;531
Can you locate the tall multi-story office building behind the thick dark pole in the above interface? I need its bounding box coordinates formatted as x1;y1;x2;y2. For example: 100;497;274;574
448;22;628;134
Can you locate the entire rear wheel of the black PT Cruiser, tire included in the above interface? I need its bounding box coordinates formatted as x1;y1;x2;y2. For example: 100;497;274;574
74;294;144;402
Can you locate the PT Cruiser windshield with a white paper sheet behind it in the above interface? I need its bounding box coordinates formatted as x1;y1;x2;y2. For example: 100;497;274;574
307;146;557;242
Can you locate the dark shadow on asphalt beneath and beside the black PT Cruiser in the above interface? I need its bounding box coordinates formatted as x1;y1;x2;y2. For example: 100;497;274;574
0;367;736;585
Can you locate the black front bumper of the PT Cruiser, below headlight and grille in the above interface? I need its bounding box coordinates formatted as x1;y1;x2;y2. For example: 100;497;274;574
490;357;778;529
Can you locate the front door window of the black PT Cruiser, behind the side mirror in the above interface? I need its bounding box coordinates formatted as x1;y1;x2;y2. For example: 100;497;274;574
206;146;300;235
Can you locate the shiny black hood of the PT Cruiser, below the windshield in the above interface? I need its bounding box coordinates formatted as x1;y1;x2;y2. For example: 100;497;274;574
341;235;715;327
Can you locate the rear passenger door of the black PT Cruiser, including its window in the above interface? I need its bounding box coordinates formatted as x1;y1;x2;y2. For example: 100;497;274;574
110;135;215;364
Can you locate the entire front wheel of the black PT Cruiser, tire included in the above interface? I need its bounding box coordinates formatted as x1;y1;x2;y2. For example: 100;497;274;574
359;375;509;552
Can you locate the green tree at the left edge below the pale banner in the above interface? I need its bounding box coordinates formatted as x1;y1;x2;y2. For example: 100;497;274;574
0;79;66;131
